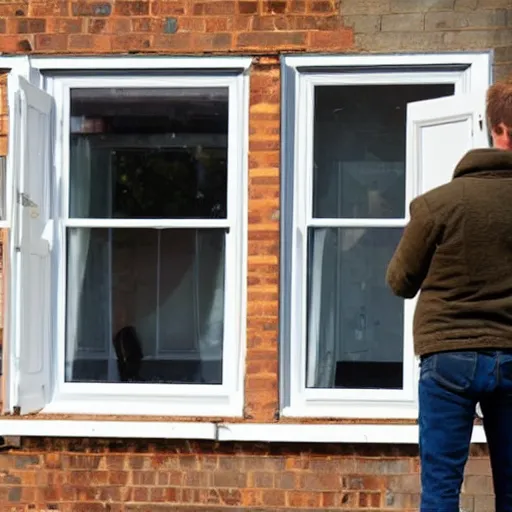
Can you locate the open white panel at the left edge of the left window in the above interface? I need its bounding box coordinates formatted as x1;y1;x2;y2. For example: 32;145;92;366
4;75;53;414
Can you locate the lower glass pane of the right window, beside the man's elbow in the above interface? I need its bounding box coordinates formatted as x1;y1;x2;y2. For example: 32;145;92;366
306;228;404;389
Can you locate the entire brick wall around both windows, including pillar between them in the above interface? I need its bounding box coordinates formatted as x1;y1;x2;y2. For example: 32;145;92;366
0;0;512;512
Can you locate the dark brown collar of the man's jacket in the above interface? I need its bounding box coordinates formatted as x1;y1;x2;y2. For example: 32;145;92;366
453;149;512;178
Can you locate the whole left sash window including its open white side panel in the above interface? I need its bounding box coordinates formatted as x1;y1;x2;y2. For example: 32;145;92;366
5;58;248;416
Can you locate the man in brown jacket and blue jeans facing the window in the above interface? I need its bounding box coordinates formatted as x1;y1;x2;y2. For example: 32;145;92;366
387;80;512;512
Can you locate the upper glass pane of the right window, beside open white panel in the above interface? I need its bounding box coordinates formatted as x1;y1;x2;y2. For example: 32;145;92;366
313;84;454;218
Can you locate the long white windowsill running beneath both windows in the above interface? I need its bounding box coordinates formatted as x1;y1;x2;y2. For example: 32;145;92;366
0;419;486;444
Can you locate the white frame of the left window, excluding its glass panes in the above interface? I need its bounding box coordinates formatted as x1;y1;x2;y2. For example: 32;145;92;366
0;57;251;417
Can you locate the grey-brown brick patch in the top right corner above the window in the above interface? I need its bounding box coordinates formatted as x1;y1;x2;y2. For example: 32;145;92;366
341;0;512;78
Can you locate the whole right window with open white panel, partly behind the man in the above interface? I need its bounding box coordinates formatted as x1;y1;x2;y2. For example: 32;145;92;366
281;55;489;418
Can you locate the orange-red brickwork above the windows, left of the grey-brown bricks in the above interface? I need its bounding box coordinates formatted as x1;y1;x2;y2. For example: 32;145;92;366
0;0;352;53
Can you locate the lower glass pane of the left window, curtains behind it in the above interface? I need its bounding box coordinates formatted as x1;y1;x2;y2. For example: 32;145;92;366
66;228;225;384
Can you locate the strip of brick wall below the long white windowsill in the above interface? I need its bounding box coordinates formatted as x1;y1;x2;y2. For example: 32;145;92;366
0;439;493;512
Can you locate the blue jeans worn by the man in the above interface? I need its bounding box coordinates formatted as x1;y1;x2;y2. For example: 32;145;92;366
419;350;512;512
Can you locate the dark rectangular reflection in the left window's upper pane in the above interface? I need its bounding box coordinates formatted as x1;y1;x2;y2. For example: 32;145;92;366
113;148;227;218
